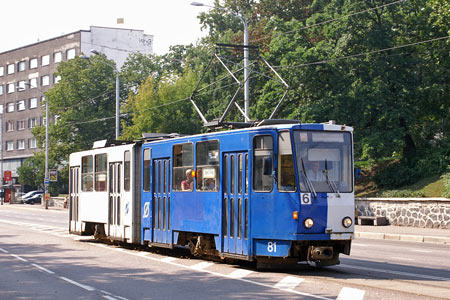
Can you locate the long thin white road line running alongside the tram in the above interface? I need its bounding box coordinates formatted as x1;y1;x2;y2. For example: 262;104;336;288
91;243;335;300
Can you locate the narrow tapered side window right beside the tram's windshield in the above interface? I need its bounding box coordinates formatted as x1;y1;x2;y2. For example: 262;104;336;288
278;131;297;192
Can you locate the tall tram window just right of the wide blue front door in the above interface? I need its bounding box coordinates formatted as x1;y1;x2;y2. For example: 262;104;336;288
253;135;273;192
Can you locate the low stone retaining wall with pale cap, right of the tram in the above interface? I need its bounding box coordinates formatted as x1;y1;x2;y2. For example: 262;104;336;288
355;198;450;229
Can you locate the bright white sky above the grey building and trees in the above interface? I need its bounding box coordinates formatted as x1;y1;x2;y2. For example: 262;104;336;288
0;0;214;55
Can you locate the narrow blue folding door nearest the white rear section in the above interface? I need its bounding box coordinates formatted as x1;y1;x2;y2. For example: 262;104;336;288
152;158;172;244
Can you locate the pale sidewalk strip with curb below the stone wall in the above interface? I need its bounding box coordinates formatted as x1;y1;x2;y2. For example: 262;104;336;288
355;225;450;245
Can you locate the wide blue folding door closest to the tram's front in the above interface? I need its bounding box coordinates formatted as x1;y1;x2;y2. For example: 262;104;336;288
222;152;249;255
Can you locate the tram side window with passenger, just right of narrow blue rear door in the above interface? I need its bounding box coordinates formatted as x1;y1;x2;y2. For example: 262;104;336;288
172;143;194;191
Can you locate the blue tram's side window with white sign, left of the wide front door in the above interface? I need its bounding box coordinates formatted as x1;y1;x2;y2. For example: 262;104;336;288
195;141;220;192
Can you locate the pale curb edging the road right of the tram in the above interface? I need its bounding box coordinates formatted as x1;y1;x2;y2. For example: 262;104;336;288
355;232;450;245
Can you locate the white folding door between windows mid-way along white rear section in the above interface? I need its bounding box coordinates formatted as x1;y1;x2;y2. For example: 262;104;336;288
108;162;122;237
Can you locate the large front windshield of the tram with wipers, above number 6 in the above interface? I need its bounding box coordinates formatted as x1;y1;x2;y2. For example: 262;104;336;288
294;130;353;194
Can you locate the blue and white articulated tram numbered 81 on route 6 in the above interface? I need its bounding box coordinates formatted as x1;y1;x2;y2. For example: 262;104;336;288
69;122;354;266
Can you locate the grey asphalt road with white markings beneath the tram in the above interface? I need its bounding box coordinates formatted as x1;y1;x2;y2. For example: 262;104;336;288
0;205;450;300
